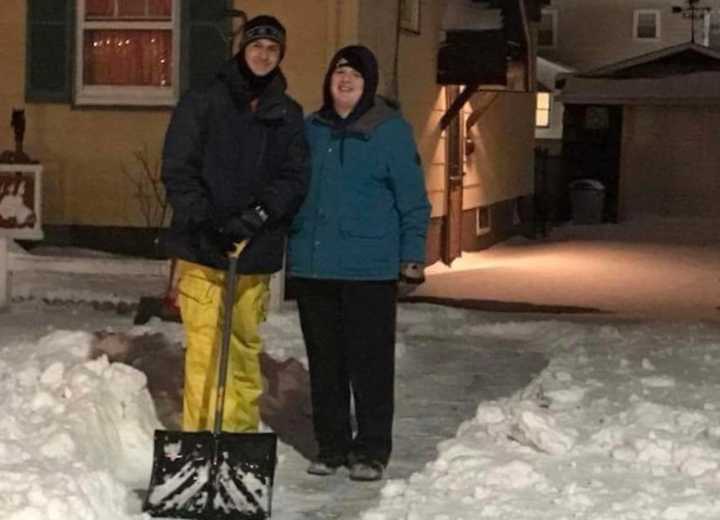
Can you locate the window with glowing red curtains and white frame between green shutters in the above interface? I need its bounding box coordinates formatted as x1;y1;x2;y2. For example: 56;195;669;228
75;0;180;105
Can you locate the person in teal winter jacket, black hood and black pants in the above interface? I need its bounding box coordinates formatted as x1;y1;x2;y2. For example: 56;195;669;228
288;45;430;480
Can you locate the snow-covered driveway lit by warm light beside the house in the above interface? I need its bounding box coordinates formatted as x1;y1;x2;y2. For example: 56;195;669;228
416;218;720;322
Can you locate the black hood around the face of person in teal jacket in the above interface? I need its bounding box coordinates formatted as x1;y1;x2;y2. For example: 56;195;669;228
320;45;379;123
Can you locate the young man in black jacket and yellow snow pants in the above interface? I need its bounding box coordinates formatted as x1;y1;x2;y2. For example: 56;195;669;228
162;16;309;432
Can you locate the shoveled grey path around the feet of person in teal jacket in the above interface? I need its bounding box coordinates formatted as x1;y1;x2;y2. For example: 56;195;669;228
273;312;547;520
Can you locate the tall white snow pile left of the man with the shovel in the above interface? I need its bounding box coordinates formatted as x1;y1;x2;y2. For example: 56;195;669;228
0;331;160;520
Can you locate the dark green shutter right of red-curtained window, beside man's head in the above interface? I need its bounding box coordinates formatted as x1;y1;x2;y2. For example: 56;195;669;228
181;0;232;90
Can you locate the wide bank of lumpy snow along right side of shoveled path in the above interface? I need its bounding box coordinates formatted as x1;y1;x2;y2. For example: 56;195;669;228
362;322;720;520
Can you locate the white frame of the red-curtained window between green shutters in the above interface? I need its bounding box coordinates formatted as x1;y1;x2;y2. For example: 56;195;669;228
74;0;182;106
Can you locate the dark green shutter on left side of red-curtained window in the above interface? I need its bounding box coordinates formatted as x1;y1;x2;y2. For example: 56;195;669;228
25;0;74;103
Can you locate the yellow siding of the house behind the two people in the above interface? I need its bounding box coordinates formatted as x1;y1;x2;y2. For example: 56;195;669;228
0;0;534;235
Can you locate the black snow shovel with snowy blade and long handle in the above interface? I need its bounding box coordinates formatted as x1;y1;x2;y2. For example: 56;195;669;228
143;242;277;520
